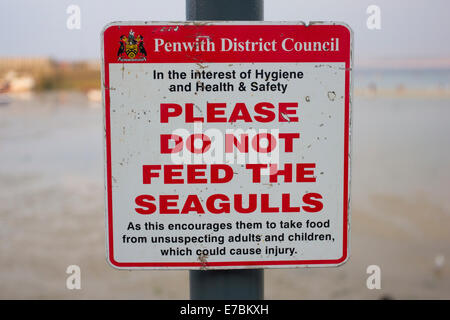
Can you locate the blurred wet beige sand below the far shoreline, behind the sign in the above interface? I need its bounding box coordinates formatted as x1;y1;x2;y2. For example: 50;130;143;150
0;93;450;300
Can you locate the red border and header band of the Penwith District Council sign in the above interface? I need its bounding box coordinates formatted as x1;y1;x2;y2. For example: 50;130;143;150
102;24;352;269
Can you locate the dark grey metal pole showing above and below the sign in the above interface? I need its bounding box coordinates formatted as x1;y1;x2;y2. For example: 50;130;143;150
186;0;264;300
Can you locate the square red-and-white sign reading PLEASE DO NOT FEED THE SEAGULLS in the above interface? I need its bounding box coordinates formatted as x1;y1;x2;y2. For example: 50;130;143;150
102;22;352;269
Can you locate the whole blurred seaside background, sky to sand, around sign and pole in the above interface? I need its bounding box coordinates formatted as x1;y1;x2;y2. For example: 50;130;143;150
0;0;450;299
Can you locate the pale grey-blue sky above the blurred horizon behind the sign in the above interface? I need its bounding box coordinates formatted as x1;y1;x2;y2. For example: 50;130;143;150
0;0;450;66
